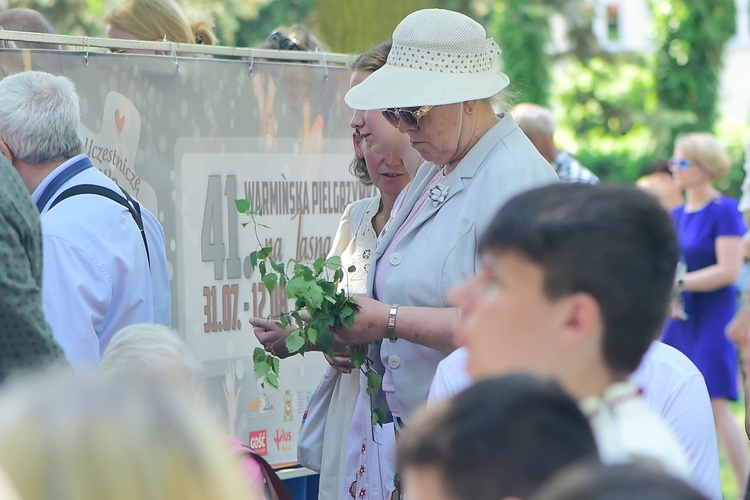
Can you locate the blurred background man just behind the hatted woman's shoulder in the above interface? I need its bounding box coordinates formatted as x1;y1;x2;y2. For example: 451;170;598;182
510;102;599;184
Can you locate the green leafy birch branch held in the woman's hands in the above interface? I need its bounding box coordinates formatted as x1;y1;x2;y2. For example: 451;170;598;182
235;199;385;425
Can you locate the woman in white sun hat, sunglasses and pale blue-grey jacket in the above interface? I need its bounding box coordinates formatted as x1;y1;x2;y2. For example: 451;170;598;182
336;9;557;498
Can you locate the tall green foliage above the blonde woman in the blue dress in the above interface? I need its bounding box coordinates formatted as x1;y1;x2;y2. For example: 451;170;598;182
651;0;736;135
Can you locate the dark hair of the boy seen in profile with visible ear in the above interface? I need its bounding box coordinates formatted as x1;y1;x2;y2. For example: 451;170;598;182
479;183;679;375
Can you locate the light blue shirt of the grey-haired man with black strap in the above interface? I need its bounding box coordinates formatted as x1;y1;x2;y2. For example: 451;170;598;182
32;155;171;370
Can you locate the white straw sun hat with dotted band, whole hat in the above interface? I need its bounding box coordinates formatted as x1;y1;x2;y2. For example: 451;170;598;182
344;9;510;110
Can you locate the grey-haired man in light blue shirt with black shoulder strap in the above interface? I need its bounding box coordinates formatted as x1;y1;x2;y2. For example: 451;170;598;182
0;71;171;370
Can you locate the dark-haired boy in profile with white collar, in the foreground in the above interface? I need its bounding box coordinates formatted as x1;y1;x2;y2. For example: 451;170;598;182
450;184;691;480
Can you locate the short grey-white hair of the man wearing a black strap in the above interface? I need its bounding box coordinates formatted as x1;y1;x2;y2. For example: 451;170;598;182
0;71;83;165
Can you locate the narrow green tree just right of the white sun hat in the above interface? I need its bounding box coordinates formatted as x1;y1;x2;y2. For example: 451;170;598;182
491;0;552;106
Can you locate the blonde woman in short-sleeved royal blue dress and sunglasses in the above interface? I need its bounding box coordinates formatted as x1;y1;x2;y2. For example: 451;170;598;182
662;133;748;491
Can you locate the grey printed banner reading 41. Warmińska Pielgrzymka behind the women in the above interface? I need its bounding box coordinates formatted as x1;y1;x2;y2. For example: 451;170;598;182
0;51;374;465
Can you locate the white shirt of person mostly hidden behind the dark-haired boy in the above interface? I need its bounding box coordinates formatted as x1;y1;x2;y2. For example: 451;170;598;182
428;342;721;500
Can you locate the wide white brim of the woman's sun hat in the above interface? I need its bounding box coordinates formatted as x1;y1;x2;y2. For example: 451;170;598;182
344;65;510;110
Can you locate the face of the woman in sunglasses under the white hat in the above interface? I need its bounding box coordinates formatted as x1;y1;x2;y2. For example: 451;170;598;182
398;103;468;165
